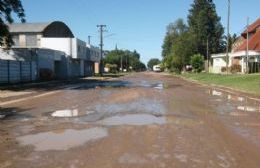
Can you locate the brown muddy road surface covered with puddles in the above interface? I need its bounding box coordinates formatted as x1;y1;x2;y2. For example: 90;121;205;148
0;72;260;168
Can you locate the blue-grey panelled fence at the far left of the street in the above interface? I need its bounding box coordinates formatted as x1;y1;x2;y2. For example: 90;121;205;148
0;60;37;84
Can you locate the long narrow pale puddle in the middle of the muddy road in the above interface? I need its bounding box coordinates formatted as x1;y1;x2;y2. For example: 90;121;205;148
98;114;166;125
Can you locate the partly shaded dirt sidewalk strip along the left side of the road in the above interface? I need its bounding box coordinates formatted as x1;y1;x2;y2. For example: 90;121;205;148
0;77;120;106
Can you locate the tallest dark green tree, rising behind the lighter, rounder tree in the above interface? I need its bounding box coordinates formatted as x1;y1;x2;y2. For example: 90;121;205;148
188;0;224;57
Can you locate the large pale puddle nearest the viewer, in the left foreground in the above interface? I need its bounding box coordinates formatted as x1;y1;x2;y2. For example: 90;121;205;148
17;127;108;151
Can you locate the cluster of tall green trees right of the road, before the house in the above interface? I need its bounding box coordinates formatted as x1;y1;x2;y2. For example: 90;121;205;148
162;0;236;72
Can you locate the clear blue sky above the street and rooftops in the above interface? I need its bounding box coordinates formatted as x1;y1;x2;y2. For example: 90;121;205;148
17;0;260;63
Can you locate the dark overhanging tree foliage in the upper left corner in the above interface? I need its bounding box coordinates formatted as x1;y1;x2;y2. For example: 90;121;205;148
0;0;25;47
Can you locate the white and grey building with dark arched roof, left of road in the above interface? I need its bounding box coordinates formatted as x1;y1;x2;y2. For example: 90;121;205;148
1;21;100;78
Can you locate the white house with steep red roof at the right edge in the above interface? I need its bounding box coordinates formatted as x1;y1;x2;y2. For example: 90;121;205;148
211;18;260;73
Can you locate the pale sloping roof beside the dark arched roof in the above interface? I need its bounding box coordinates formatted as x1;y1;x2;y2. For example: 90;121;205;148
8;22;52;33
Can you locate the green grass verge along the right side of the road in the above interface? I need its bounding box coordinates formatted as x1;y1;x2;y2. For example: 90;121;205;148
181;73;260;95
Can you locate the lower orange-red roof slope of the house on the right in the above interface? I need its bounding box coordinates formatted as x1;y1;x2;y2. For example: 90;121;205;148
236;30;260;51
